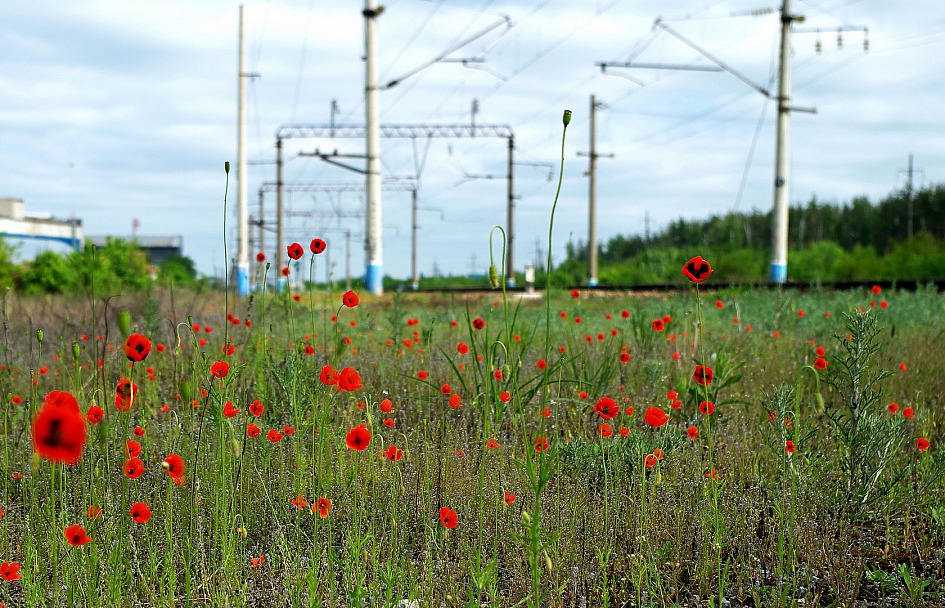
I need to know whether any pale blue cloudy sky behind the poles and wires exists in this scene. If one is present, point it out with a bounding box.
[0,0,945,278]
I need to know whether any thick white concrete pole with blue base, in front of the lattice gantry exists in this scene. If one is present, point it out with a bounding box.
[362,0,384,295]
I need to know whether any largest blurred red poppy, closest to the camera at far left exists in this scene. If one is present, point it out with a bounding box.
[33,391,88,464]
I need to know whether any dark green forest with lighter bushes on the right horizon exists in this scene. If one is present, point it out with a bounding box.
[553,185,945,285]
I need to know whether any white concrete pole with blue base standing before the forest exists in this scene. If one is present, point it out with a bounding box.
[770,0,795,284]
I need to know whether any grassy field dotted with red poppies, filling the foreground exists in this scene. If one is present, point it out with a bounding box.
[0,274,945,606]
